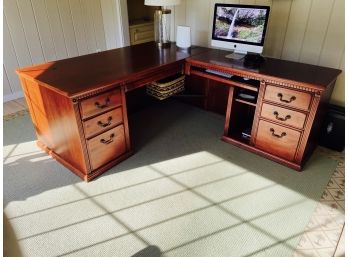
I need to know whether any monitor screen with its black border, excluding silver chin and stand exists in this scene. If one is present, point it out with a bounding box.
[212,4,270,46]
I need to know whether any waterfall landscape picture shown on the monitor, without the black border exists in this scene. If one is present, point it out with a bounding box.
[214,6,266,43]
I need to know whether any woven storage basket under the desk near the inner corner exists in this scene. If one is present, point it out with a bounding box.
[146,74,185,100]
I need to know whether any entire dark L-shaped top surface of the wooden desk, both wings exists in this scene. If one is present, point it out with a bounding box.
[17,42,341,97]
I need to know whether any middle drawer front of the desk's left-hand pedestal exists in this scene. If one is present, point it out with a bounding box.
[83,107,123,138]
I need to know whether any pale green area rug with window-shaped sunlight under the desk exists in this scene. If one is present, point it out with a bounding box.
[4,101,336,257]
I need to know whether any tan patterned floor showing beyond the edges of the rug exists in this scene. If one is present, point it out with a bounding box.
[4,98,345,254]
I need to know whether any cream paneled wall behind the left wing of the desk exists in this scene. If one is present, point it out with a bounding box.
[3,0,128,101]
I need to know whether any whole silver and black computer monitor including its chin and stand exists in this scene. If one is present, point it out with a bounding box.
[211,4,270,59]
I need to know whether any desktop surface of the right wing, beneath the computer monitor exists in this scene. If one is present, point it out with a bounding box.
[187,49,341,90]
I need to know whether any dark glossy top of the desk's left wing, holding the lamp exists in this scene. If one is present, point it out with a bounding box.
[17,42,210,97]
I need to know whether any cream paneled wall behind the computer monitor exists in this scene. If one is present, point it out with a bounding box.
[173,0,345,105]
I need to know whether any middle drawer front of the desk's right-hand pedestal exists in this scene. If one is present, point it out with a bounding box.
[261,103,306,129]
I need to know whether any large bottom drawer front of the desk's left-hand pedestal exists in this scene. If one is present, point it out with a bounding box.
[87,125,126,170]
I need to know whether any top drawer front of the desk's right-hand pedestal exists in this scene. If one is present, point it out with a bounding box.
[264,85,311,110]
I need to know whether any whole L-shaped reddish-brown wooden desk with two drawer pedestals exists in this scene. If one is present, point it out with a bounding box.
[17,42,341,181]
